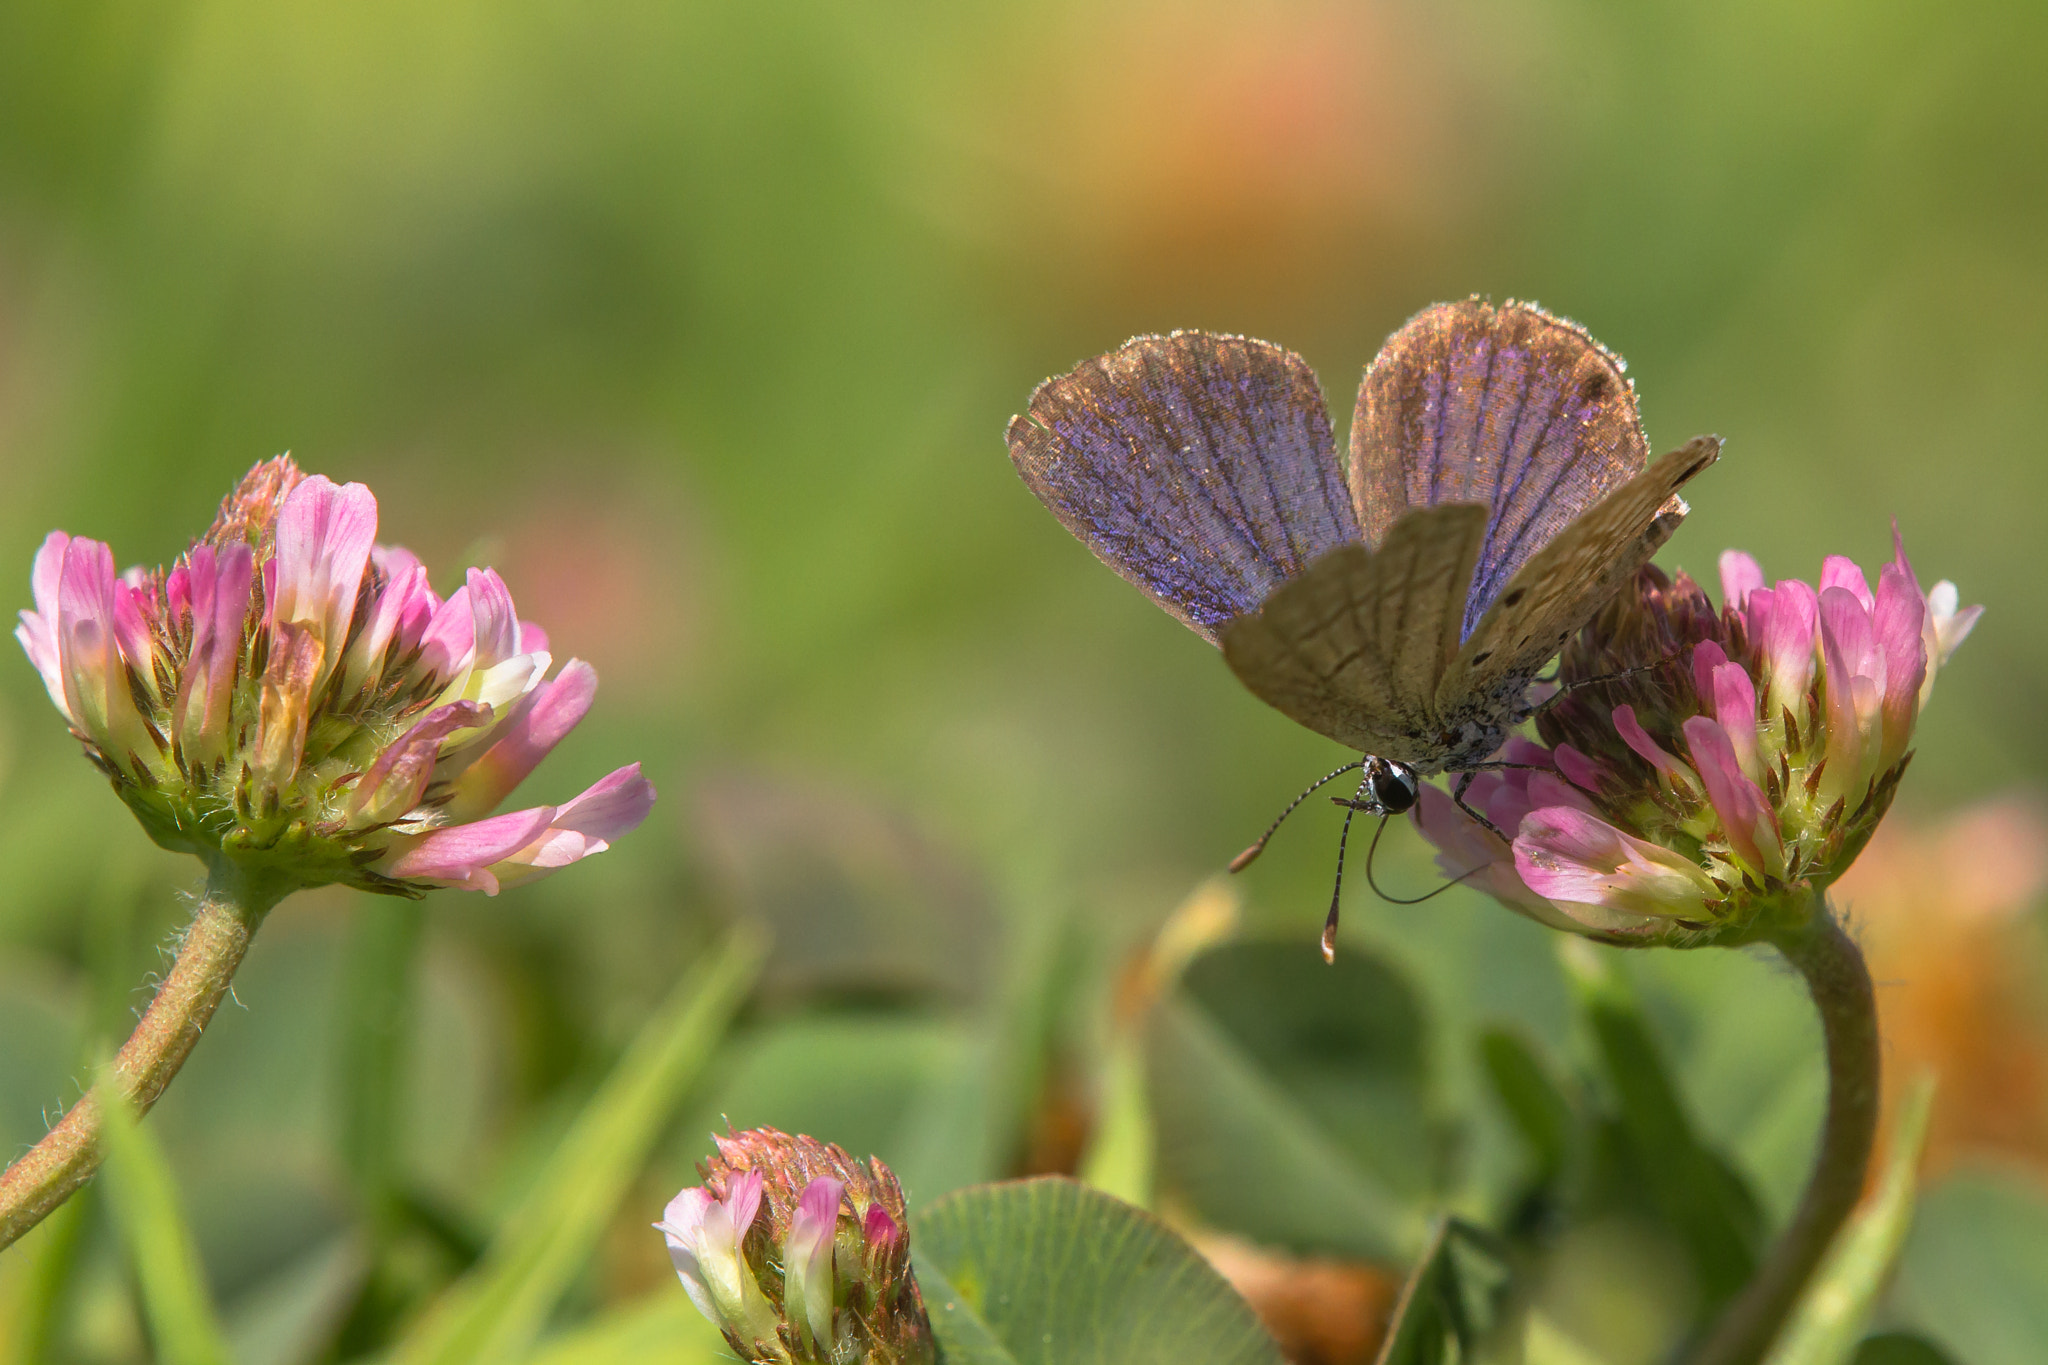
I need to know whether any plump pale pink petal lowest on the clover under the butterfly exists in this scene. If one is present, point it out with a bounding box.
[1516,806,1718,927]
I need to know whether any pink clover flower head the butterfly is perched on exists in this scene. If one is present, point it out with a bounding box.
[1415,528,1982,945]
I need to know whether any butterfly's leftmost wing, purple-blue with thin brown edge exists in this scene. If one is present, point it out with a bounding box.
[1008,332,1358,643]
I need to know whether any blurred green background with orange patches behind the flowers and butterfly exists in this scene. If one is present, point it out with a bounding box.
[0,0,2048,1361]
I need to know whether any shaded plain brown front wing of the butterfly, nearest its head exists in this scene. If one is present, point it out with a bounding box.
[1223,503,1487,763]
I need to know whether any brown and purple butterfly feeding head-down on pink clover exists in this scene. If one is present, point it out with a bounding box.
[1008,297,1720,954]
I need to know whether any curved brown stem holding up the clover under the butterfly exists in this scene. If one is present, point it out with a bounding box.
[1692,894,1878,1365]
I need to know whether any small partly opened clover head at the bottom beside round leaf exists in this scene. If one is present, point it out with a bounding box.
[655,1128,936,1365]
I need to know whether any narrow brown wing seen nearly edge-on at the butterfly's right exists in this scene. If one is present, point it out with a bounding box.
[1436,436,1720,714]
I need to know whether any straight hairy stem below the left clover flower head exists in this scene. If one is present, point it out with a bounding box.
[0,860,289,1248]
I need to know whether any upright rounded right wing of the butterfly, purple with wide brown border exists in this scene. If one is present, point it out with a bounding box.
[1352,299,1649,636]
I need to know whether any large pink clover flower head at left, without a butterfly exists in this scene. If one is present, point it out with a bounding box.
[14,456,653,894]
